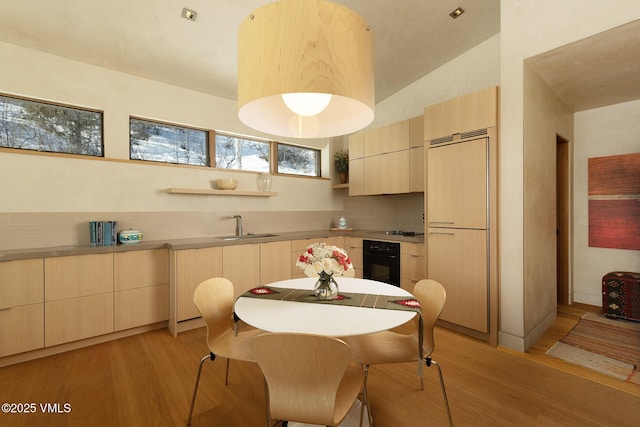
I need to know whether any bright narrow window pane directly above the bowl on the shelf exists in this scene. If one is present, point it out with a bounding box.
[216,133,271,172]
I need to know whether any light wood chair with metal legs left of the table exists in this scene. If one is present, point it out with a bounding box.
[187,277,265,425]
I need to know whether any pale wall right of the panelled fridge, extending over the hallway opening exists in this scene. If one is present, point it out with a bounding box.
[499,0,640,351]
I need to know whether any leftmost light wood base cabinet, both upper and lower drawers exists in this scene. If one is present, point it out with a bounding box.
[0,258,44,357]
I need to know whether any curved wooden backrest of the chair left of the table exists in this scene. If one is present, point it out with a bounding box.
[193,277,238,347]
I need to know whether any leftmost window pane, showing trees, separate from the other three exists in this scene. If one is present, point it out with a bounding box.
[0,96,104,157]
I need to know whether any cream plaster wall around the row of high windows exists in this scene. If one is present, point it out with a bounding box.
[0,39,342,212]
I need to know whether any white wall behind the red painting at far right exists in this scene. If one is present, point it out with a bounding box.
[573,100,640,306]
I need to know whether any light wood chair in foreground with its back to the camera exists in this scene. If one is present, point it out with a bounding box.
[251,333,368,426]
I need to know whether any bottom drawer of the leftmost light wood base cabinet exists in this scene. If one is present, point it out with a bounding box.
[0,303,44,357]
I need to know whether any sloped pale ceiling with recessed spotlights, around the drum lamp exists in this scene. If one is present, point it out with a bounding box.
[0,0,500,102]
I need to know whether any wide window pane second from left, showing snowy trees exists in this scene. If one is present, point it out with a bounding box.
[129,119,209,166]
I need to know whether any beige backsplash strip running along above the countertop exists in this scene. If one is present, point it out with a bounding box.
[0,193,424,250]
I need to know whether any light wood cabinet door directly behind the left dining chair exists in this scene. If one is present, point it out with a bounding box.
[170,247,223,327]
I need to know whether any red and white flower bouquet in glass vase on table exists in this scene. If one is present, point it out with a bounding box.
[296,243,353,299]
